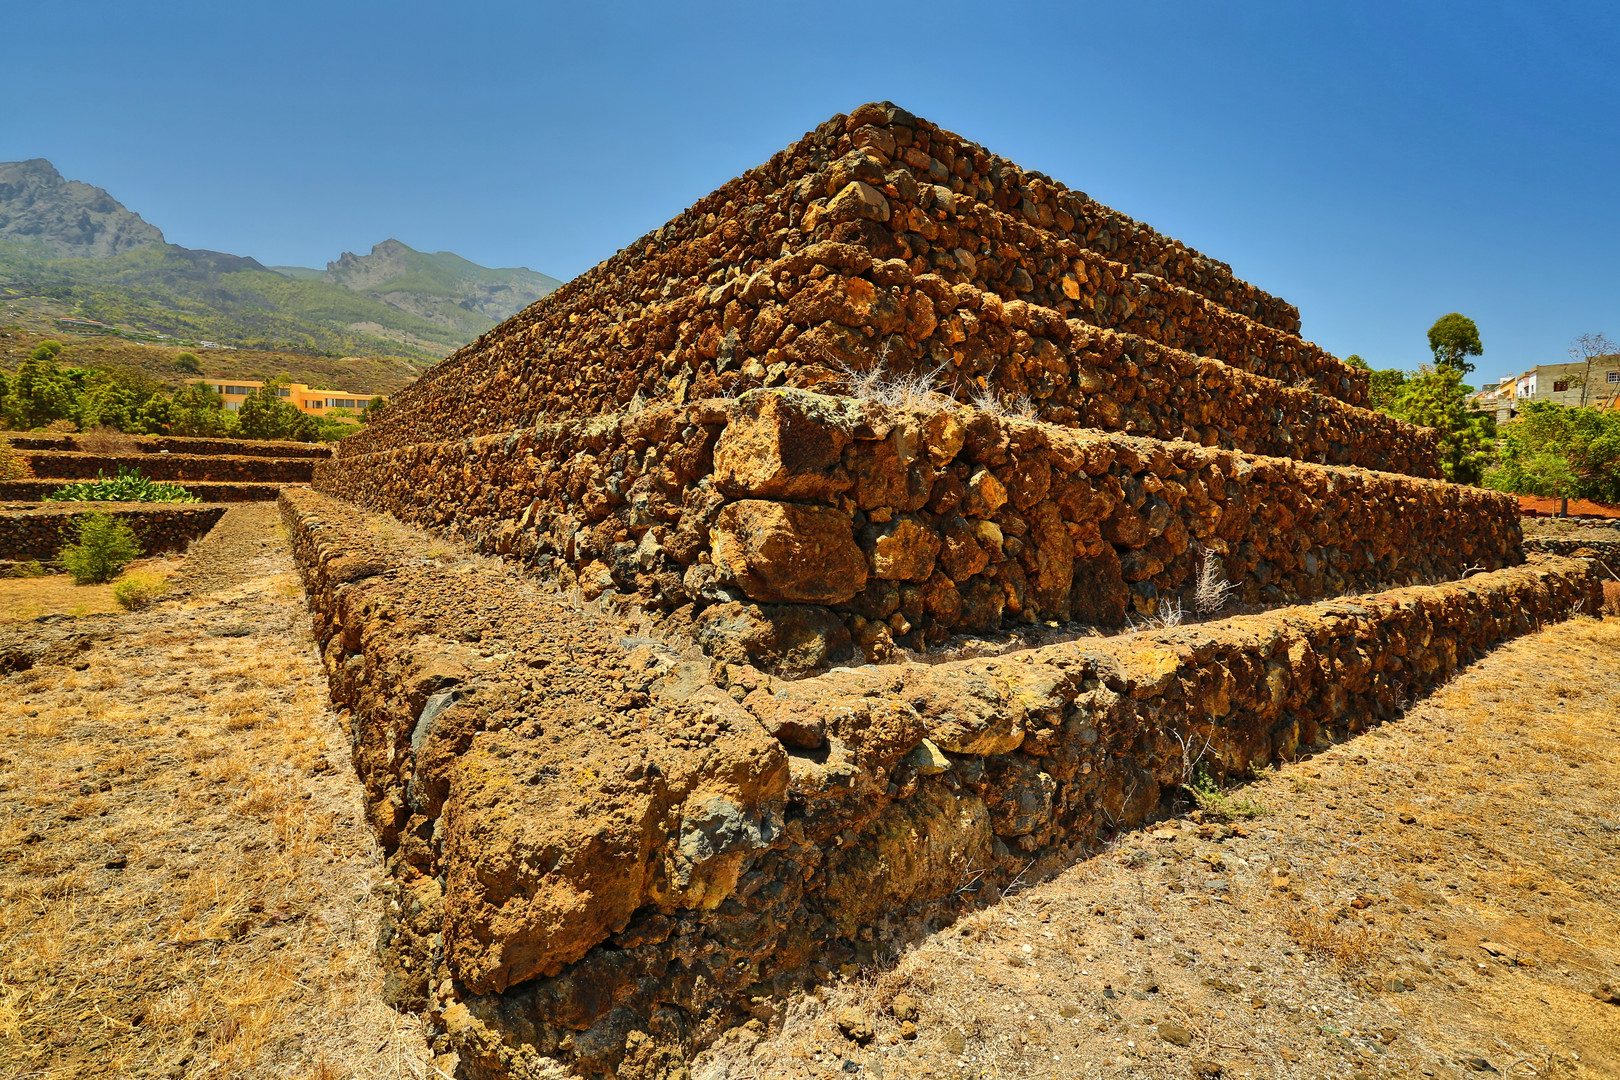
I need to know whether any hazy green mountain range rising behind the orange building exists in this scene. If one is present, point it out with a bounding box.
[0,159,559,363]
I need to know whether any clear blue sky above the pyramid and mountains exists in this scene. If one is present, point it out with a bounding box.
[0,0,1620,381]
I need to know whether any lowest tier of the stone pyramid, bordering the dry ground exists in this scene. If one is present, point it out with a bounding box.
[282,491,1597,1078]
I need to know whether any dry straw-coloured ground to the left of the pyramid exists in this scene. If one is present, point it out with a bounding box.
[0,504,429,1080]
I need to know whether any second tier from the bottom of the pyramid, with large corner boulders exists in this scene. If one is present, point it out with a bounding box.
[314,392,1521,670]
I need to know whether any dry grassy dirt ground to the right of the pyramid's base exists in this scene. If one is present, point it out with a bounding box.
[693,619,1620,1080]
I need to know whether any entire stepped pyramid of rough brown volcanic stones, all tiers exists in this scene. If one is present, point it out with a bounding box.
[284,104,1594,1077]
